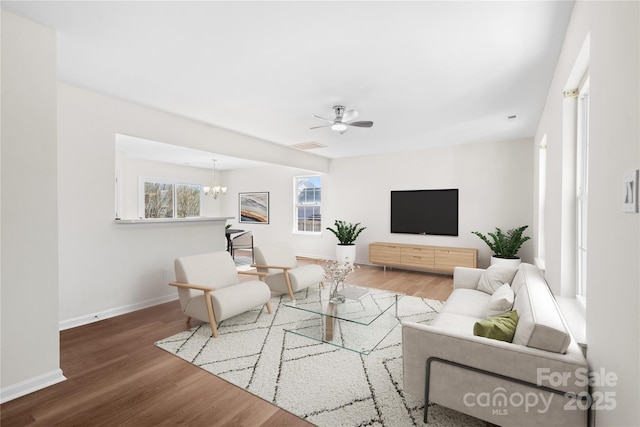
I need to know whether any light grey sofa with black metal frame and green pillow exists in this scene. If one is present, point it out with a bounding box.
[402,263,589,426]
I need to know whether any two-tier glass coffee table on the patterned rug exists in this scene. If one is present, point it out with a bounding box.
[284,284,403,354]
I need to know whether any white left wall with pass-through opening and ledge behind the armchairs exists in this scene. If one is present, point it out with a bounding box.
[58,84,328,327]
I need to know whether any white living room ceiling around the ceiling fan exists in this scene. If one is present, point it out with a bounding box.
[2,1,573,169]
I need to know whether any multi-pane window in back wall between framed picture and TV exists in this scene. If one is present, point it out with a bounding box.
[294,175,322,234]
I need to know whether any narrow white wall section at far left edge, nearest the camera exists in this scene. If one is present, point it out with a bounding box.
[0,12,64,401]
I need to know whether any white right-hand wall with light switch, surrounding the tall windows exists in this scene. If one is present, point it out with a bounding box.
[536,1,640,426]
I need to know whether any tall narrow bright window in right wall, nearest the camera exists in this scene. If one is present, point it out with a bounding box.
[576,76,589,305]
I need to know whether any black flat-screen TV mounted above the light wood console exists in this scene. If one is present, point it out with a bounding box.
[391,188,458,236]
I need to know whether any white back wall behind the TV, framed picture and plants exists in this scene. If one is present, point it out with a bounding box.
[222,139,533,266]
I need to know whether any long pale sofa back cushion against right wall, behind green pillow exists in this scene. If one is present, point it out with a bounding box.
[512,263,571,353]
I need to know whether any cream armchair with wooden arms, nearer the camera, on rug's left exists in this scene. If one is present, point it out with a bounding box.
[169,251,271,338]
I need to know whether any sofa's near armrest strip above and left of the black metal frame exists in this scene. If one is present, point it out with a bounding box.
[402,321,588,398]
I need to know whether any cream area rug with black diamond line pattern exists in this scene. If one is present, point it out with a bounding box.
[156,289,485,427]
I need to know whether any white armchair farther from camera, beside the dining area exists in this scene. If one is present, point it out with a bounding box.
[252,243,324,301]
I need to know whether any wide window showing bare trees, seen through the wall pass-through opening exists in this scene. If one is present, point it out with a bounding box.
[140,178,202,218]
